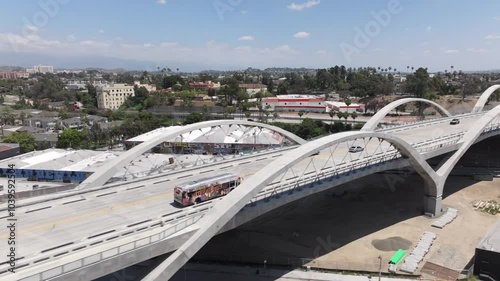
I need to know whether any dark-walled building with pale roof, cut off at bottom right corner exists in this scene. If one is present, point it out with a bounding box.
[474,221,500,280]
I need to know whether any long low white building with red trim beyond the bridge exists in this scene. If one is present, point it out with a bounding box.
[262,95,325,112]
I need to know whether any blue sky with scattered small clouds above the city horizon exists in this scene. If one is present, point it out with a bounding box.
[0,0,500,71]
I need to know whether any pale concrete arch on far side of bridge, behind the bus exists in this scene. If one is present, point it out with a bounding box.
[78,120,306,189]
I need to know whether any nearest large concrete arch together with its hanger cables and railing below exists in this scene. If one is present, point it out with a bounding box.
[143,132,437,280]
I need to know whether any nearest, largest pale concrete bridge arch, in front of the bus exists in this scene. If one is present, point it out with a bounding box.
[143,132,437,281]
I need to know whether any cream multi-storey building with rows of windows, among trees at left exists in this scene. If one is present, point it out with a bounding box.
[96,84,135,110]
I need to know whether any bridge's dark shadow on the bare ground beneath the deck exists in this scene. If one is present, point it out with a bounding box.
[193,171,476,268]
